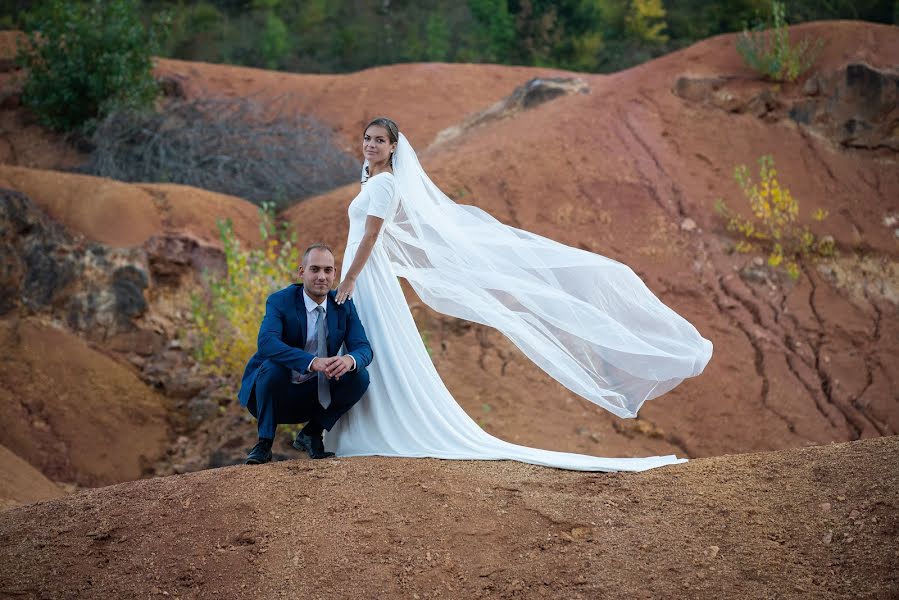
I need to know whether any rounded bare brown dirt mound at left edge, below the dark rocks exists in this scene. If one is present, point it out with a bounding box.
[0,317,168,488]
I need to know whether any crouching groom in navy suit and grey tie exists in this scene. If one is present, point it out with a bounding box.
[238,244,372,465]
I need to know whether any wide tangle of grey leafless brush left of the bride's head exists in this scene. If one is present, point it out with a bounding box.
[80,96,359,208]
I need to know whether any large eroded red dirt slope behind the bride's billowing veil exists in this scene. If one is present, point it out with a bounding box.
[286,22,899,457]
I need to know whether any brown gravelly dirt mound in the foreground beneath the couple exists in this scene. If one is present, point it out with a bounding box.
[0,437,899,600]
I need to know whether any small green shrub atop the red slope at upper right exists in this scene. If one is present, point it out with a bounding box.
[737,0,823,81]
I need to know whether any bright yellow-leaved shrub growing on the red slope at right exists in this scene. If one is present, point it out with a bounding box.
[715,155,834,279]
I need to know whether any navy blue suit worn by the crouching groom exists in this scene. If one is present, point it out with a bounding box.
[238,284,372,439]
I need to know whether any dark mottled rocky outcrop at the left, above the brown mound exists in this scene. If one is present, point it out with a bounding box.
[0,190,230,422]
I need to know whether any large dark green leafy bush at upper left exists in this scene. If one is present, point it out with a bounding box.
[16,0,158,131]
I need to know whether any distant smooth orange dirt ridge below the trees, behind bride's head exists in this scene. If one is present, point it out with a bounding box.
[156,59,576,151]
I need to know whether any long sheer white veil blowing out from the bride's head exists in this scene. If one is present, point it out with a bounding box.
[370,134,712,417]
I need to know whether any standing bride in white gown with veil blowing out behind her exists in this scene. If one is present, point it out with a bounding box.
[325,118,712,471]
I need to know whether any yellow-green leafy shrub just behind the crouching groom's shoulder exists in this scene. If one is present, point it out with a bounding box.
[188,203,299,386]
